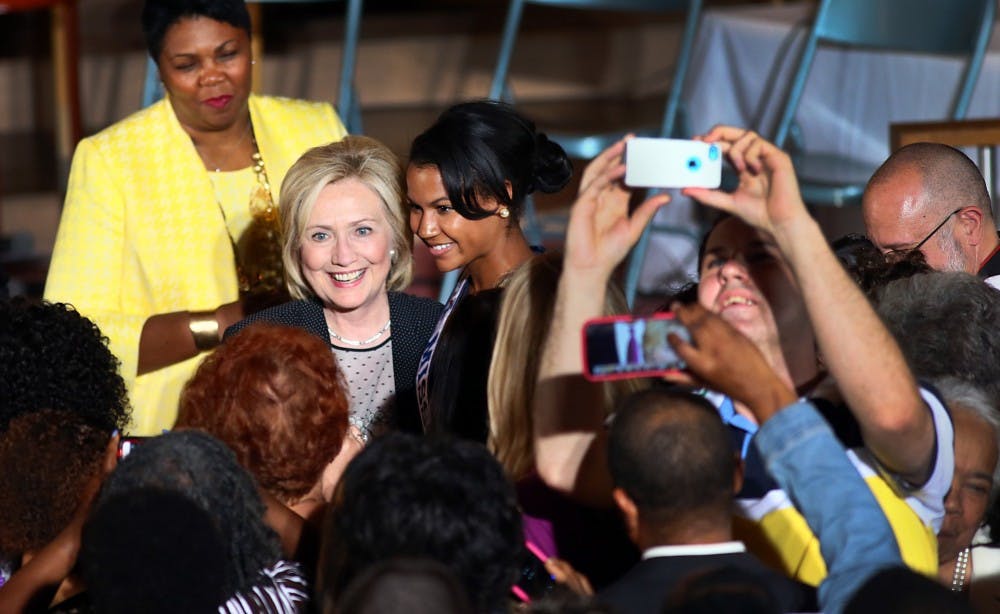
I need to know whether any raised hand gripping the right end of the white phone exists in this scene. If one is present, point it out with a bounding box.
[683,126,809,234]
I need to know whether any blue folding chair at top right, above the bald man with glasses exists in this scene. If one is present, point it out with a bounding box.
[771,0,996,207]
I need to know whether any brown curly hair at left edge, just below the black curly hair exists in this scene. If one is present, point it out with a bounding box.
[0,409,110,555]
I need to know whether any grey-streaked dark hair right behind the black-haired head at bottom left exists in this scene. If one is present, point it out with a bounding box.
[95,430,281,595]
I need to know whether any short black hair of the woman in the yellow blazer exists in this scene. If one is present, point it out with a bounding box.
[142,0,250,62]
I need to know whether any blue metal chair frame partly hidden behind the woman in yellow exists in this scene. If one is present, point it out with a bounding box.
[142,0,364,134]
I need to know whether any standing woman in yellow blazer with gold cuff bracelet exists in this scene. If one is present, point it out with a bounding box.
[45,0,345,435]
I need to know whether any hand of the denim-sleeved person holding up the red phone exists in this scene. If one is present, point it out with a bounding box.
[664,303,796,423]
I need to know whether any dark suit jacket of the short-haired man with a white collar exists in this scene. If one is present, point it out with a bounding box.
[598,552,816,614]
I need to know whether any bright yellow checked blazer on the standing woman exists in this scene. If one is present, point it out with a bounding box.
[45,96,346,435]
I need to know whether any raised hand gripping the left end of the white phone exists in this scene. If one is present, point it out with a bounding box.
[566,136,670,276]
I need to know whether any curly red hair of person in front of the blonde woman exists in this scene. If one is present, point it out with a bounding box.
[177,322,350,504]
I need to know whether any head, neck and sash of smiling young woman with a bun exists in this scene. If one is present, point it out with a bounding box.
[406,101,572,427]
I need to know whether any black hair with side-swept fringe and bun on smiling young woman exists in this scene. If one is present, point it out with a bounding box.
[410,100,573,220]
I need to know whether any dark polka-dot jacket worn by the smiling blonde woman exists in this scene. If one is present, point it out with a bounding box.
[225,292,444,433]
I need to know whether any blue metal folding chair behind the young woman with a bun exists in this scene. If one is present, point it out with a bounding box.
[440,0,702,304]
